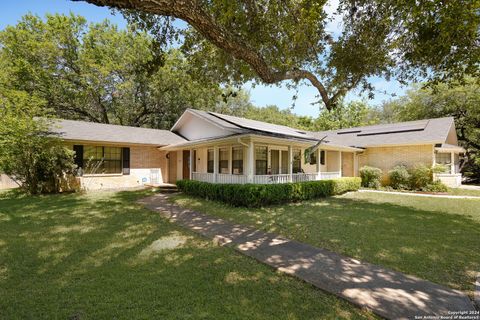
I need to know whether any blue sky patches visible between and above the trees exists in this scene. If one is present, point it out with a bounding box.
[0,0,405,117]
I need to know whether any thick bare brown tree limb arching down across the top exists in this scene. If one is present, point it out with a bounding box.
[72,0,339,110]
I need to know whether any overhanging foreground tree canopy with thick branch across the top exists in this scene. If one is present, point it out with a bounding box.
[74,0,480,109]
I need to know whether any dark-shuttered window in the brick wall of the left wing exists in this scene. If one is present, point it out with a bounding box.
[83,146,122,174]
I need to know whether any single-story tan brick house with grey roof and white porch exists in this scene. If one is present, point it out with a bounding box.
[0,109,465,189]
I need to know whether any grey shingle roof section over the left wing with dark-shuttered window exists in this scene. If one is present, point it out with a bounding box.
[52,119,186,146]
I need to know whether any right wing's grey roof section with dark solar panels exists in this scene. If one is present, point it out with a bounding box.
[310,117,455,148]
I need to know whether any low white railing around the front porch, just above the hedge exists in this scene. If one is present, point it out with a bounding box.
[192,172,341,184]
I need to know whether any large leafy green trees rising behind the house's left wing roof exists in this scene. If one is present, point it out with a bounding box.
[0,14,229,128]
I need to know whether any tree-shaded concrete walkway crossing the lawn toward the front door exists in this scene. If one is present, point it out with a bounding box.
[140,194,475,319]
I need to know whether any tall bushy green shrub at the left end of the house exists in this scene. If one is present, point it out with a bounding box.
[0,90,75,194]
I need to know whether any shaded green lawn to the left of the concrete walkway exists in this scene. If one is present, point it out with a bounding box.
[0,191,373,319]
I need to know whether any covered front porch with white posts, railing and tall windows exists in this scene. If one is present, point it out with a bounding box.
[163,136,359,184]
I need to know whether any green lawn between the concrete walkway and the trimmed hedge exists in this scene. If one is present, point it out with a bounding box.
[174,192,480,295]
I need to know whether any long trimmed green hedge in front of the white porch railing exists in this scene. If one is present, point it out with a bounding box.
[177,177,361,207]
